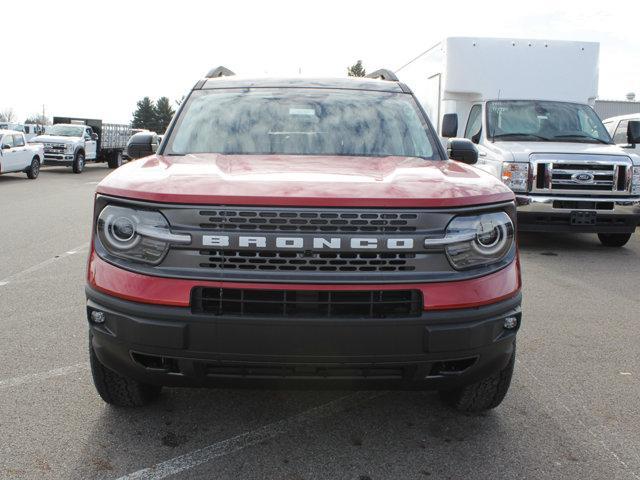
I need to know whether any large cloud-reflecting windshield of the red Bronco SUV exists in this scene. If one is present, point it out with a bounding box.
[163,88,440,159]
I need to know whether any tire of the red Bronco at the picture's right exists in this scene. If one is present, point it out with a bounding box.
[440,345,516,413]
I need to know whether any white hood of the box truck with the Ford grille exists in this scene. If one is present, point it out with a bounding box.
[485,142,632,162]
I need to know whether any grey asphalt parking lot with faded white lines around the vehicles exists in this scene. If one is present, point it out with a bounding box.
[0,165,640,480]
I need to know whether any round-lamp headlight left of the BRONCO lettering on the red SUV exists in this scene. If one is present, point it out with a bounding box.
[96,205,191,265]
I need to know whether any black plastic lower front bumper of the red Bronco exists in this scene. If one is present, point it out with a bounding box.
[87,288,521,389]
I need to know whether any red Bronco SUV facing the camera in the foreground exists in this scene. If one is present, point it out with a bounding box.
[86,69,521,411]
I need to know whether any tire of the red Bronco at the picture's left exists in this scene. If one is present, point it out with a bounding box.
[89,340,162,407]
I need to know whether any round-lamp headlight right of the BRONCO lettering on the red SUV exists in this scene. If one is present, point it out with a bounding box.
[425,212,514,270]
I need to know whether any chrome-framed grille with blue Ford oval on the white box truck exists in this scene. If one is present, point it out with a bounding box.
[532,155,632,195]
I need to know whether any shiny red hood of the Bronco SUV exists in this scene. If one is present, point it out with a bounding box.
[97,154,514,207]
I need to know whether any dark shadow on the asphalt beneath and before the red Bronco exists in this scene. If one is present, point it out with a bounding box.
[73,378,553,479]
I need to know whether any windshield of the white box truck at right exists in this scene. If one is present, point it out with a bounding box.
[487,100,612,144]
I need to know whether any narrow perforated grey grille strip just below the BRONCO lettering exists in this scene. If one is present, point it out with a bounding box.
[200,250,420,272]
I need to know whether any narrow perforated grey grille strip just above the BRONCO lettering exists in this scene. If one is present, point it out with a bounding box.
[200,208,418,233]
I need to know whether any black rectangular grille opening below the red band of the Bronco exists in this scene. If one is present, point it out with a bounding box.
[191,287,422,318]
